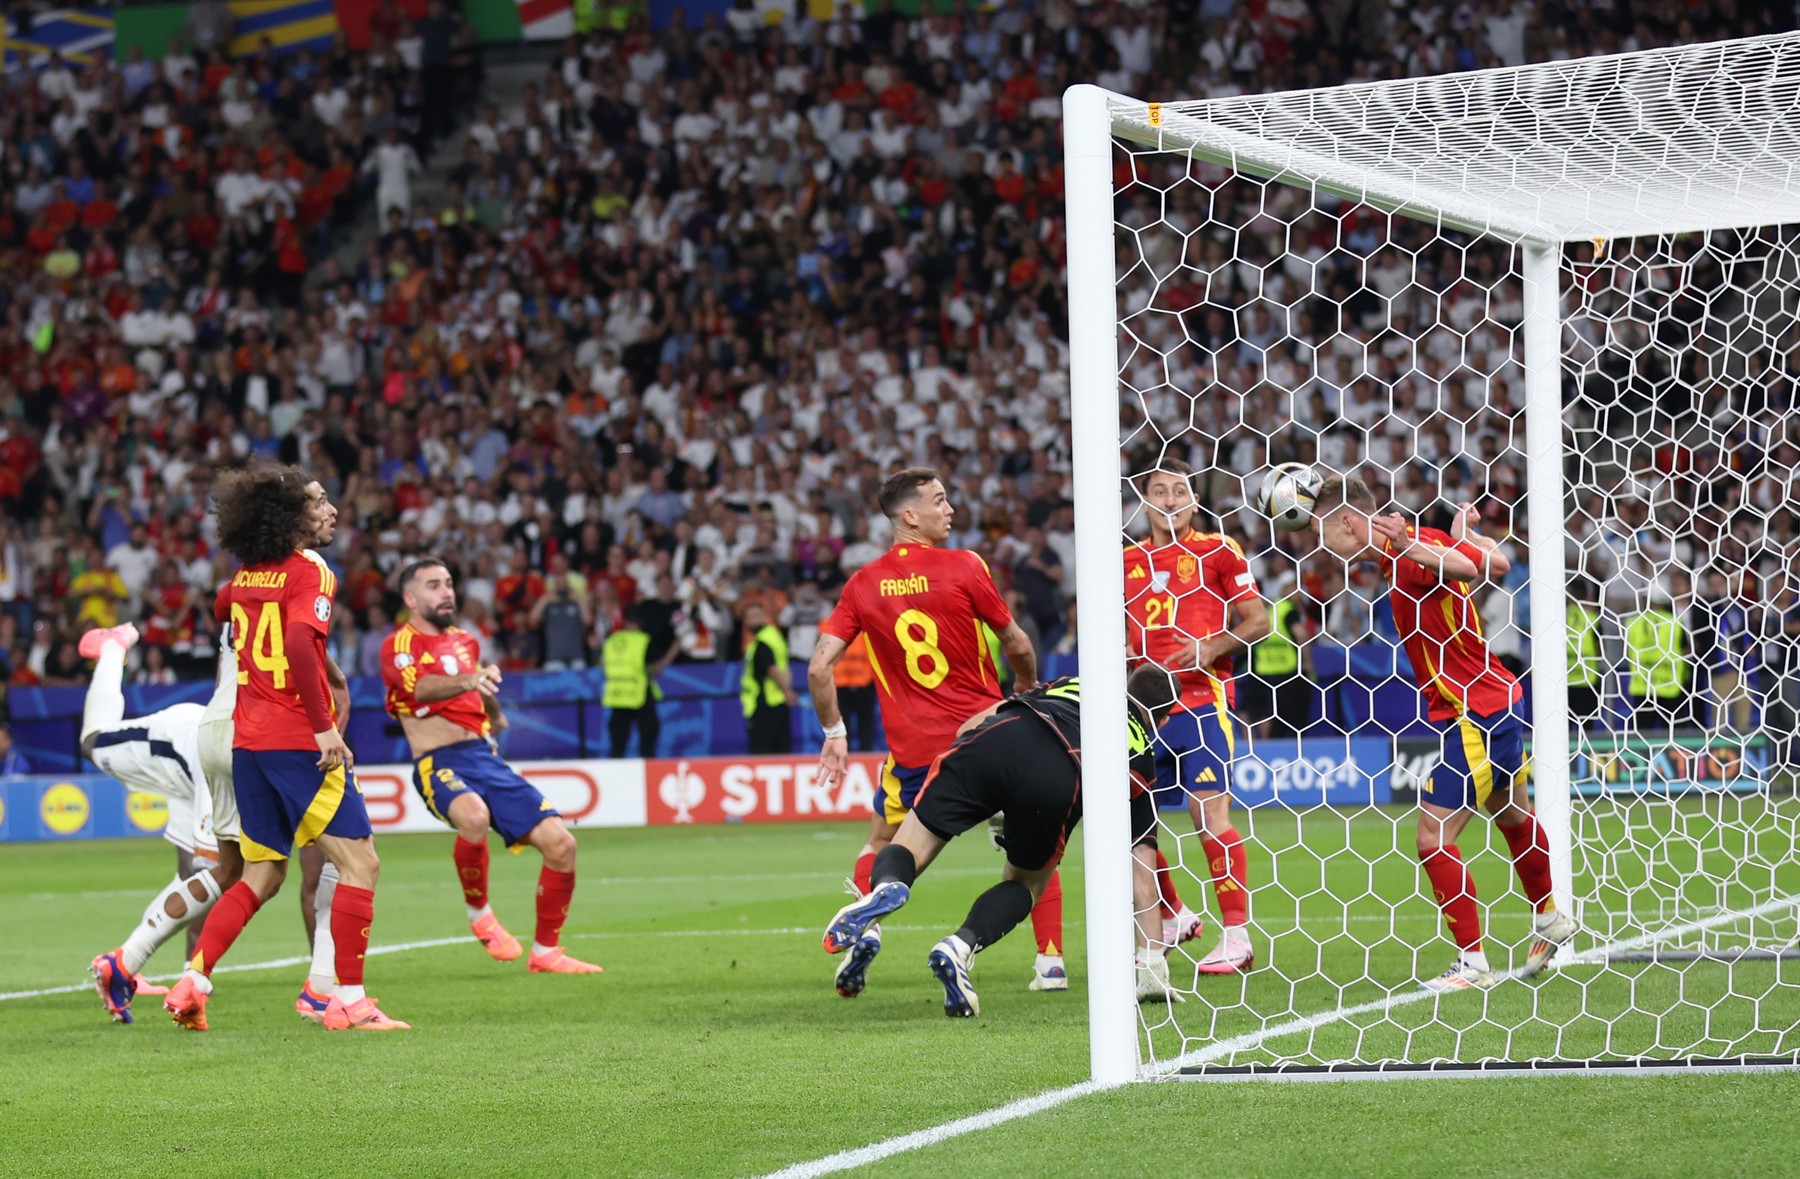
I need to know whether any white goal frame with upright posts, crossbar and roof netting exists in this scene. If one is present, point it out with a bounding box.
[1064,34,1800,1082]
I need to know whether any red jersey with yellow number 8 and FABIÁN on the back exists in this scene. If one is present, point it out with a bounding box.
[819,544,1012,769]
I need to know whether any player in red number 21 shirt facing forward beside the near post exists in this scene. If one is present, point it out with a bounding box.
[1125,459,1269,974]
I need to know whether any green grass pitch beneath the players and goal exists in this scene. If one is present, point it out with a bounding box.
[0,812,1800,1175]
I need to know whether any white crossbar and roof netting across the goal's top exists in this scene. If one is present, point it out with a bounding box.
[1109,32,1800,243]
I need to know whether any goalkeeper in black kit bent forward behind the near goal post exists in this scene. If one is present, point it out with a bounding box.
[824,668,1175,1017]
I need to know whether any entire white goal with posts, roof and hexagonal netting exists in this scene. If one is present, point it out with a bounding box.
[1066,36,1800,1080]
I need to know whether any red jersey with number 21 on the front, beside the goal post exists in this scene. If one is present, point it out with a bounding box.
[1125,531,1256,709]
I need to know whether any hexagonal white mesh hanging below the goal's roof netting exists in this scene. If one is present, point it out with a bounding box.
[1071,39,1800,1075]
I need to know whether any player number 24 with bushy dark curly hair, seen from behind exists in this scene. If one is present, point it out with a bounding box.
[162,464,409,1031]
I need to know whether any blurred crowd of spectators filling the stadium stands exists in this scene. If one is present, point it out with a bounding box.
[0,0,1800,748]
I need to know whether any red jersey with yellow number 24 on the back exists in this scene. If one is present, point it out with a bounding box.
[214,549,337,751]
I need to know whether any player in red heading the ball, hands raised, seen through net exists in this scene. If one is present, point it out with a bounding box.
[1312,475,1577,992]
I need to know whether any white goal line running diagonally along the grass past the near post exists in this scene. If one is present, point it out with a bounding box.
[761,896,1800,1179]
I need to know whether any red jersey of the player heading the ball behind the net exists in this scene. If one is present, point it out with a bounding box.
[1381,527,1525,720]
